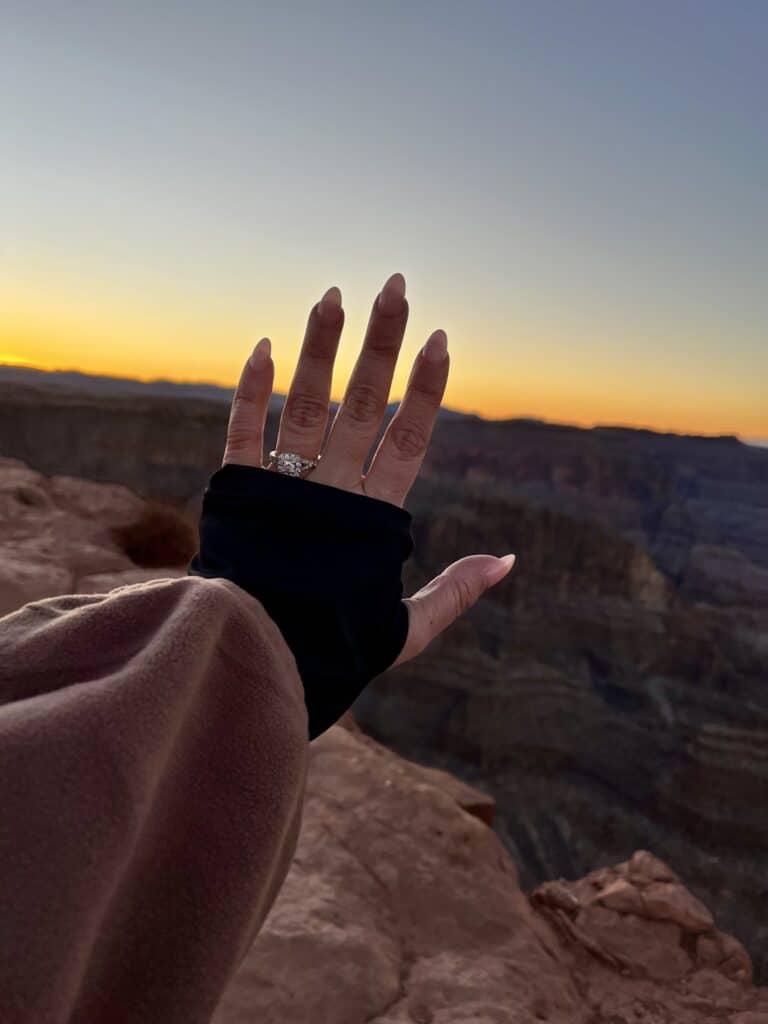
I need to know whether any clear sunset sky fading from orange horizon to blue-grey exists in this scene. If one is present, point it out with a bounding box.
[0,0,768,438]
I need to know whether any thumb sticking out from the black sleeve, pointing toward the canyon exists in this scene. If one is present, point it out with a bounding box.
[393,554,515,666]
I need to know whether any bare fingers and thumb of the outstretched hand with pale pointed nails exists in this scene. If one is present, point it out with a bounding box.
[223,273,515,665]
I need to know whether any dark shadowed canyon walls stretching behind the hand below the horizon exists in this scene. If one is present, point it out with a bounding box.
[0,368,768,983]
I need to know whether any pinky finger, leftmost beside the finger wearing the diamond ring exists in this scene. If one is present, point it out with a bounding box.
[222,338,274,468]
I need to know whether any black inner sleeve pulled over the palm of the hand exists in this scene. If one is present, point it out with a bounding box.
[188,464,414,739]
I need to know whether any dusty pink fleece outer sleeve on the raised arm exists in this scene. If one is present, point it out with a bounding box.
[0,577,307,1024]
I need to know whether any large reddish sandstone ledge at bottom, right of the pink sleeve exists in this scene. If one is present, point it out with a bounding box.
[214,726,768,1024]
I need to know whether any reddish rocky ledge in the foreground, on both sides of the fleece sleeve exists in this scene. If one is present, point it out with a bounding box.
[0,459,768,1024]
